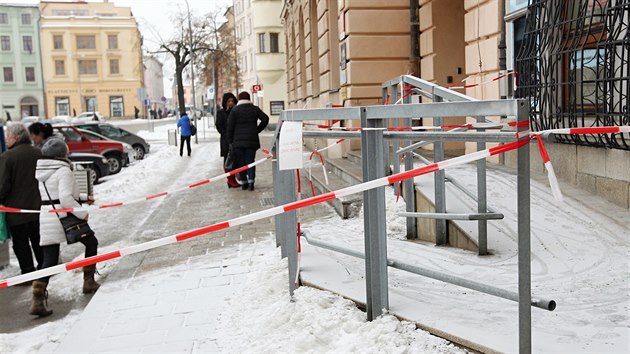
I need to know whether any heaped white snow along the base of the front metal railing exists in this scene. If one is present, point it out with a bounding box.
[217,241,465,353]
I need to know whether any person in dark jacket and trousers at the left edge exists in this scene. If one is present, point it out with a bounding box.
[0,123,44,276]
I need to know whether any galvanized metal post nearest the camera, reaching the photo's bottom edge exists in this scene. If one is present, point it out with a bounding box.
[516,100,532,354]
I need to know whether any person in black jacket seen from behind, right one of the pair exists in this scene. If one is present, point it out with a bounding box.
[227,91,269,191]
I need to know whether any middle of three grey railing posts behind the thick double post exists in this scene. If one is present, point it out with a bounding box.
[433,95,448,245]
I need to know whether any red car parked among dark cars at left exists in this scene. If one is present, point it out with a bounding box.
[54,125,129,175]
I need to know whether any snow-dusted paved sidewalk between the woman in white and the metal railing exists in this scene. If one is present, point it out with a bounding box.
[53,136,332,353]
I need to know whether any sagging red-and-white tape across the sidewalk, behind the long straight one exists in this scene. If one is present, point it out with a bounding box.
[0,149,273,214]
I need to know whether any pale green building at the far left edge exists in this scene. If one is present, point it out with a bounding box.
[0,4,46,121]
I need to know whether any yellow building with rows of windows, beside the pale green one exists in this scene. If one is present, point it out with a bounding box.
[40,1,144,117]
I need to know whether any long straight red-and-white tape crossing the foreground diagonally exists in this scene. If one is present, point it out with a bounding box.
[0,137,532,288]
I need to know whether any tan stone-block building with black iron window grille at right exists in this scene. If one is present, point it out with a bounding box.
[282,0,630,208]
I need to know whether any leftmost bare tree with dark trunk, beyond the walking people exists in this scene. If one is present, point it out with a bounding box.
[153,11,215,114]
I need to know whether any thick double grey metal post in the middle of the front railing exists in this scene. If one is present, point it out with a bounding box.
[361,108,389,321]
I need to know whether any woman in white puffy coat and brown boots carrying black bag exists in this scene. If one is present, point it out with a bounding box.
[29,139,100,317]
